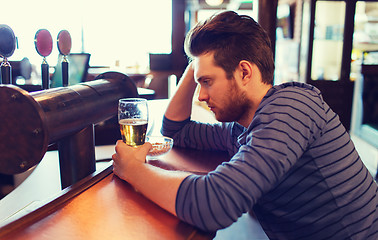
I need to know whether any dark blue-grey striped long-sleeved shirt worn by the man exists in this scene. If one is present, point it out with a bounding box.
[162,83,378,240]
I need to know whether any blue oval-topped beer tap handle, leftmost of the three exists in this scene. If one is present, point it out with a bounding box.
[0,24,16,84]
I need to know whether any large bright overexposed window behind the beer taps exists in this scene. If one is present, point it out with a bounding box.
[0,0,172,73]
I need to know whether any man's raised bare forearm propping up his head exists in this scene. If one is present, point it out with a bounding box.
[165,65,197,121]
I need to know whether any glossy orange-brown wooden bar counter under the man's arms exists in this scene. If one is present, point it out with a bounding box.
[0,101,228,240]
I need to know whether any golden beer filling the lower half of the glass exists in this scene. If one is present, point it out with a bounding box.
[119,119,148,147]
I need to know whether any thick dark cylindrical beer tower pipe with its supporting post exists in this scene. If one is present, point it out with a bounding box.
[0,72,139,188]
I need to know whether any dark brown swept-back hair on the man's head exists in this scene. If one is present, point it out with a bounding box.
[185,11,274,84]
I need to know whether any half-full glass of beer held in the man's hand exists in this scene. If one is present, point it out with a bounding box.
[118,98,148,147]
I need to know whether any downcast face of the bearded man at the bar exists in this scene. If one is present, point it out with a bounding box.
[193,53,249,122]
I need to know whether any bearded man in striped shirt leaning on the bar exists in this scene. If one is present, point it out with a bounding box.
[113,12,378,239]
